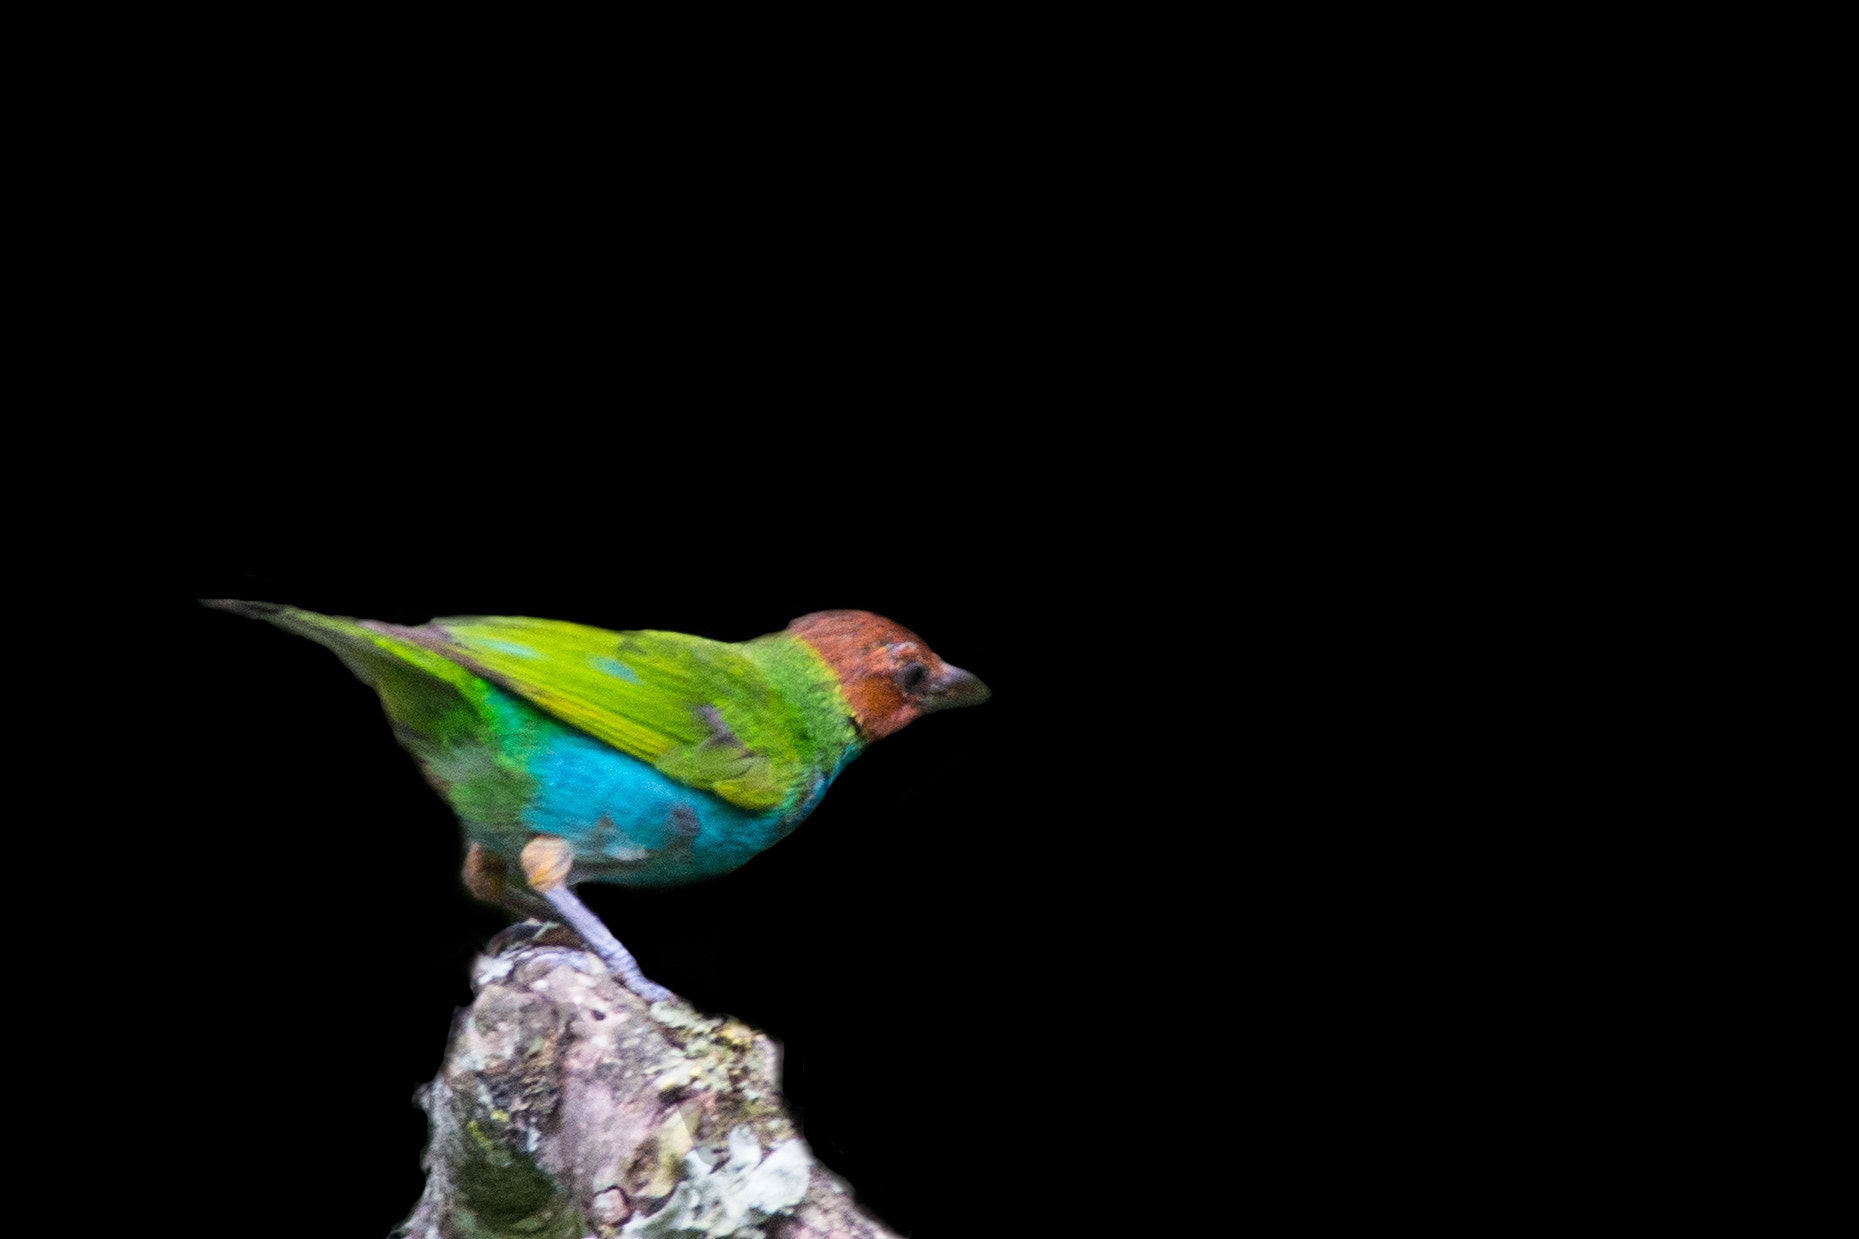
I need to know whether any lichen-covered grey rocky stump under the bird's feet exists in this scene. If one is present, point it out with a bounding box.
[394,923,894,1239]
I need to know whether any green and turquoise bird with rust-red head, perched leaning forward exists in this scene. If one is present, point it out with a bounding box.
[206,599,989,1001]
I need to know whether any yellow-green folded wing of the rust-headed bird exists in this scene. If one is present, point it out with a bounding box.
[409,616,811,809]
